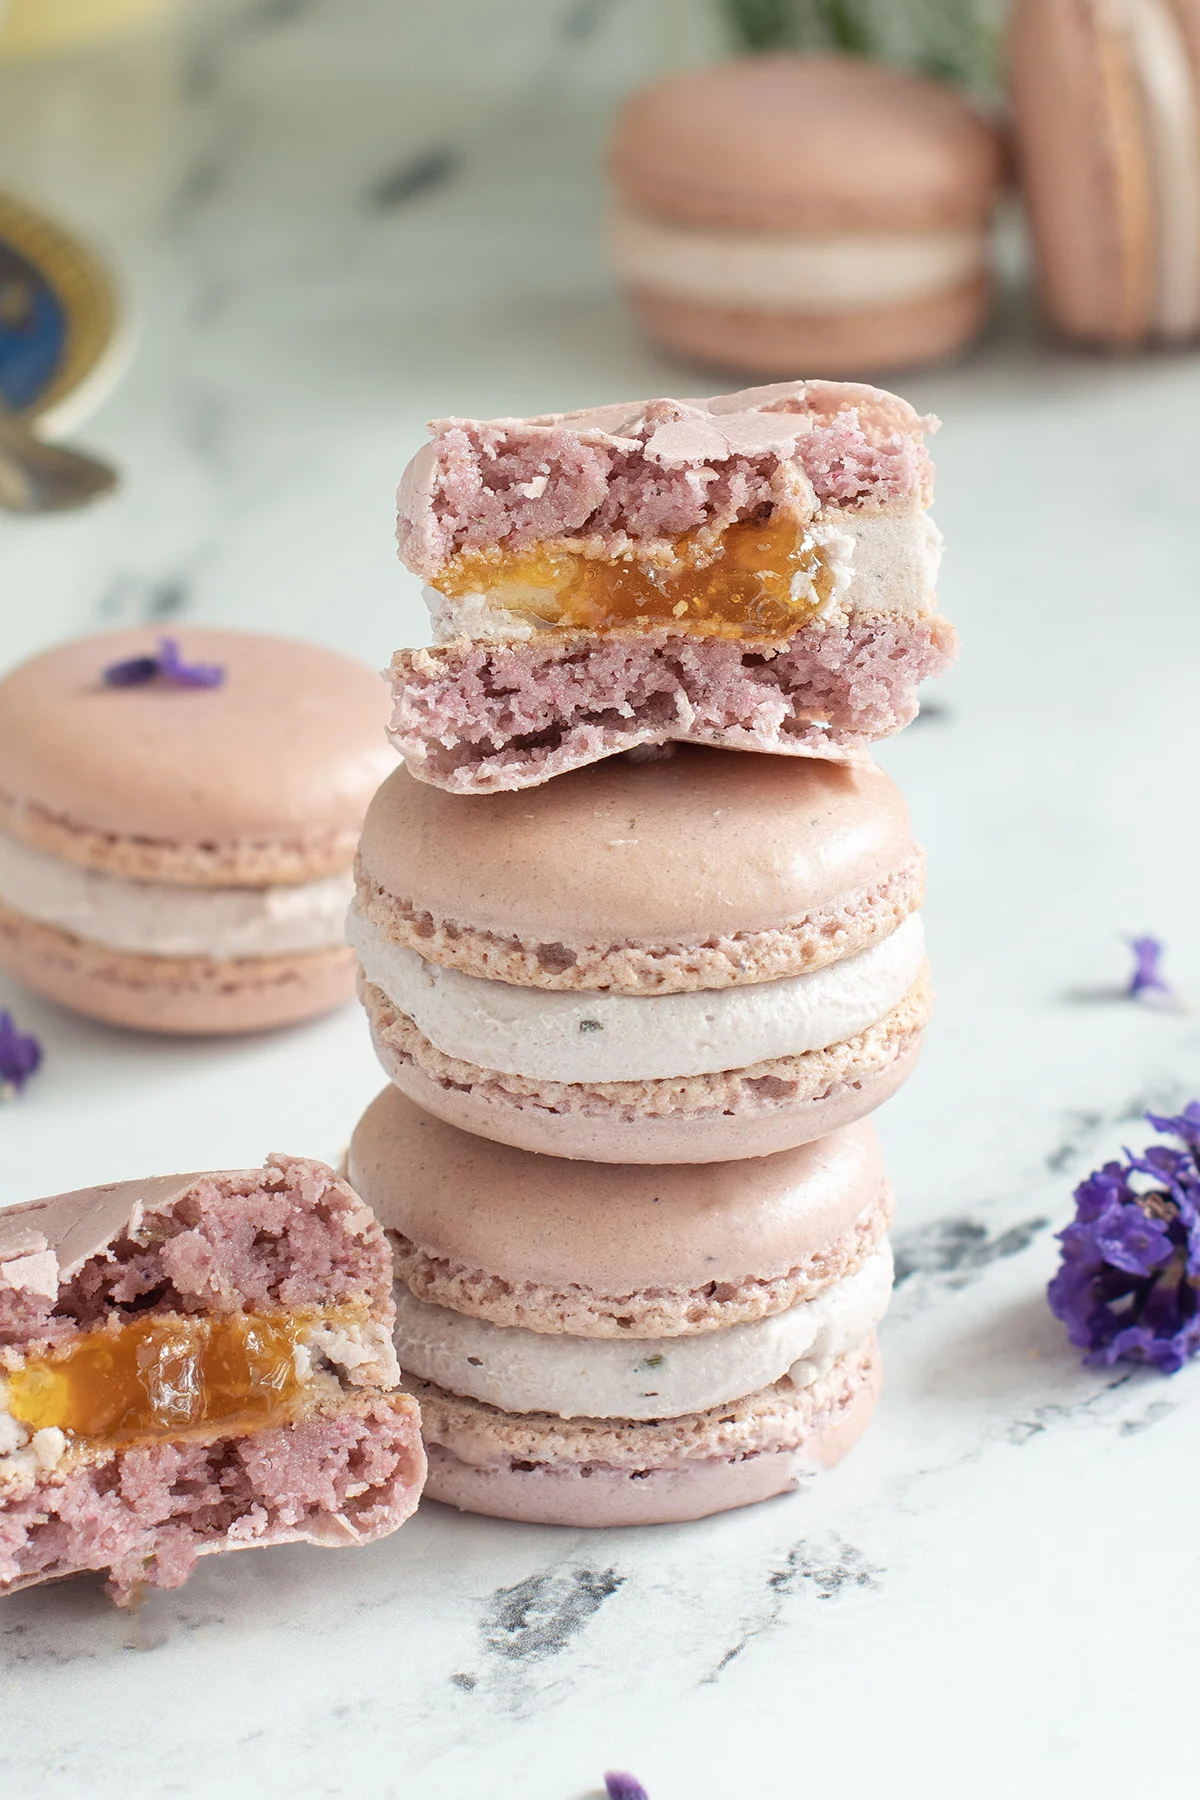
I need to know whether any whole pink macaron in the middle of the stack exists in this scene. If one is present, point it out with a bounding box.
[347,745,930,1163]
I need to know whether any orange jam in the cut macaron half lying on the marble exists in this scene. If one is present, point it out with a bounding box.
[4,1312,332,1444]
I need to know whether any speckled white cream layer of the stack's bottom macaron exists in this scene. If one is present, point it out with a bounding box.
[396,1242,892,1418]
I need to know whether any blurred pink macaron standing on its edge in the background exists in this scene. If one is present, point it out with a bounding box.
[1011,0,1200,349]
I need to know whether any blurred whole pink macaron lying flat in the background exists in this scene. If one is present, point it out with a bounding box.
[610,56,1000,376]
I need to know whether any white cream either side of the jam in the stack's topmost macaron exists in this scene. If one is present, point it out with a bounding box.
[425,508,943,644]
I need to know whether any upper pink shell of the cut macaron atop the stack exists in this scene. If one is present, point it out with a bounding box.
[398,382,937,578]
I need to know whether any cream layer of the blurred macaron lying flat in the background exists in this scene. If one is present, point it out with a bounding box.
[610,211,986,313]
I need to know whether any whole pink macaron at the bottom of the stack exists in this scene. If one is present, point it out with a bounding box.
[349,1089,892,1526]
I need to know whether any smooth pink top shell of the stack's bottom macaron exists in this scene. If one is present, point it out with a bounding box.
[347,1087,892,1337]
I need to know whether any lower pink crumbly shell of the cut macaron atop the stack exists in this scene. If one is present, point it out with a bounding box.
[390,616,955,794]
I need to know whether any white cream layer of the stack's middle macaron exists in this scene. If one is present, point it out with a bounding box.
[347,907,925,1084]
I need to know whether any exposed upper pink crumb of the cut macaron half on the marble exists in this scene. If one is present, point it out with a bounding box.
[0,1156,390,1350]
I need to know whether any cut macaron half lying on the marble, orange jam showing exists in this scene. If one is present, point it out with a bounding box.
[0,1157,425,1604]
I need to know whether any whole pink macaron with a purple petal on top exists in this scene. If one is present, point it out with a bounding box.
[0,626,396,1033]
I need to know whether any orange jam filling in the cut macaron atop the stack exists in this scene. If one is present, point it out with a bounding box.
[434,518,833,637]
